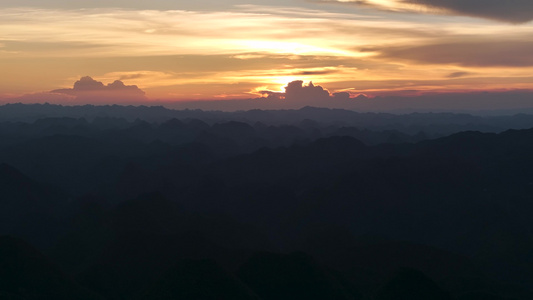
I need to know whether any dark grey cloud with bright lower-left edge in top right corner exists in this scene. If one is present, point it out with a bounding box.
[326,0,533,23]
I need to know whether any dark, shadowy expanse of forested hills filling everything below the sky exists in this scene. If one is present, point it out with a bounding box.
[0,105,533,300]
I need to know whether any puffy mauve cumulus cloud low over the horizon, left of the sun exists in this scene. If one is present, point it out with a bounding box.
[50,76,147,103]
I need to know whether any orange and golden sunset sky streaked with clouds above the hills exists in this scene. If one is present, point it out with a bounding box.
[0,0,533,110]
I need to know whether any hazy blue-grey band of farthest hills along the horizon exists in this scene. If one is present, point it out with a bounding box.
[5,104,533,134]
